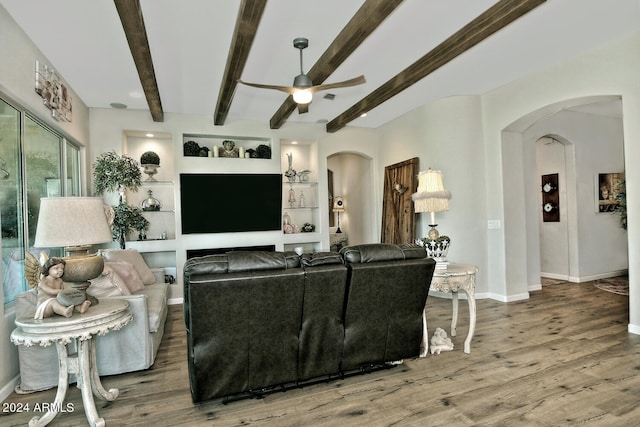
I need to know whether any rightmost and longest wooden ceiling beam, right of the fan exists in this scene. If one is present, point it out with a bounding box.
[326,0,546,133]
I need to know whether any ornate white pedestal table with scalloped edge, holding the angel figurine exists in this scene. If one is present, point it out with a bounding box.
[11,298,133,426]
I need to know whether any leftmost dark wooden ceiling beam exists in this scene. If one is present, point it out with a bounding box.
[114,0,164,122]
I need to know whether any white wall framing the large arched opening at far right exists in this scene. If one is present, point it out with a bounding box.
[483,33,640,333]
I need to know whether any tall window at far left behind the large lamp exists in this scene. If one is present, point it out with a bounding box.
[0,98,81,304]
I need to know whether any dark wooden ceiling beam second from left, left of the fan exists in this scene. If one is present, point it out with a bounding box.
[213,0,267,126]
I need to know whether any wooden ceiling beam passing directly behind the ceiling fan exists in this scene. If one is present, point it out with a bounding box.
[269,0,402,129]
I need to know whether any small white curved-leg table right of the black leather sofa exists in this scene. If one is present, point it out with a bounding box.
[420,263,478,357]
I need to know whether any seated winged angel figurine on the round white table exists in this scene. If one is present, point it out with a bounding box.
[26,252,91,319]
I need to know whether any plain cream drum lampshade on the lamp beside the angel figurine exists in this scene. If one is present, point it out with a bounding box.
[34,197,112,248]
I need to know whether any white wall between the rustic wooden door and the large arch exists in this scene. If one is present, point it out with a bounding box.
[377,96,488,297]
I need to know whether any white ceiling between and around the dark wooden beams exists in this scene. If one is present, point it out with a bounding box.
[0,0,640,127]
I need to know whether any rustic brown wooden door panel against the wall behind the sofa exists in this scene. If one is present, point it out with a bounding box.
[381,157,418,244]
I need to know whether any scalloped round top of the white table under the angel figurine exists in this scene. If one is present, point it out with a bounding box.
[11,298,133,346]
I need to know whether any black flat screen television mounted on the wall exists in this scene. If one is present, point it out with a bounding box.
[180,173,282,234]
